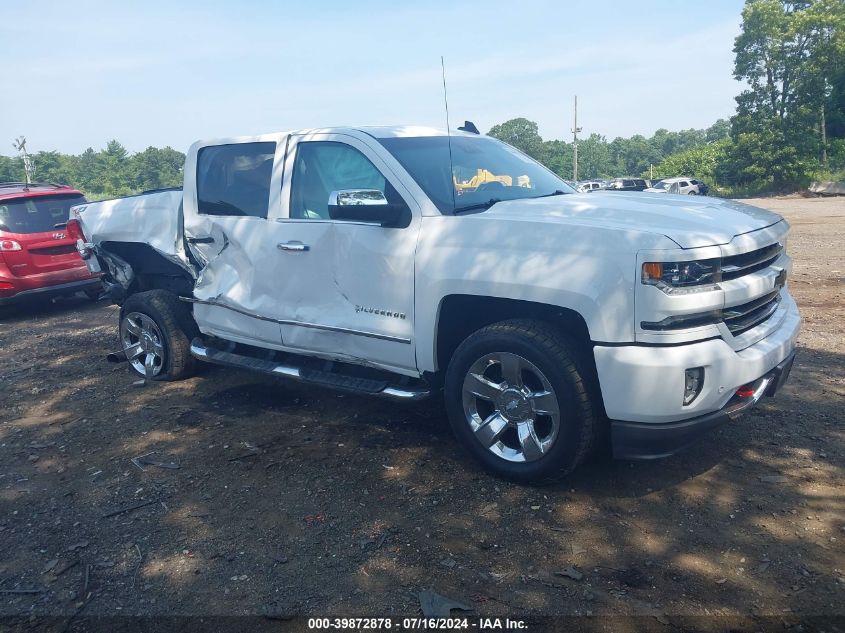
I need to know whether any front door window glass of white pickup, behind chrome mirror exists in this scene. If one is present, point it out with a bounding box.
[290,141,390,220]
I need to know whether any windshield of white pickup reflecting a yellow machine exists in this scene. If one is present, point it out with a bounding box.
[378,136,574,214]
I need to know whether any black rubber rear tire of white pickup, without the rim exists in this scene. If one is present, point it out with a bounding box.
[120,290,199,381]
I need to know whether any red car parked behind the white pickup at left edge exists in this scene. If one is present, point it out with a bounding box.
[0,182,101,305]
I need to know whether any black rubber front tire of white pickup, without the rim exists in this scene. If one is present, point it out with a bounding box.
[444,319,601,483]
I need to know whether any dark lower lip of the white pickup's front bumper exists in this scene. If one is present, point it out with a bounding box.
[611,351,795,459]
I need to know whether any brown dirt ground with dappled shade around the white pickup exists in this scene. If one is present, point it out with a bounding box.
[0,198,845,631]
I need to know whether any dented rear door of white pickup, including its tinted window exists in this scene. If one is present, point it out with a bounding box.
[185,134,286,349]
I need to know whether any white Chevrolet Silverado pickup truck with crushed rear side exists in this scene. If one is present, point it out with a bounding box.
[68,127,800,481]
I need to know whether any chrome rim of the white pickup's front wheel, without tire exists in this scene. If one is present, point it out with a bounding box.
[463,352,560,462]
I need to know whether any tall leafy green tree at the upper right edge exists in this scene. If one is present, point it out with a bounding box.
[730,0,845,189]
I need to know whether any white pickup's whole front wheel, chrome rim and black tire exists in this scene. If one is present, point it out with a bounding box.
[445,320,598,482]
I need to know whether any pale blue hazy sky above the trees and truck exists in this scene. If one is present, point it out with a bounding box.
[0,0,743,155]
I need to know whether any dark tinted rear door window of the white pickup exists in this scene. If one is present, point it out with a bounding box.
[197,143,276,218]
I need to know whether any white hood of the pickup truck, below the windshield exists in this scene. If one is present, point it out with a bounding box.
[479,191,783,248]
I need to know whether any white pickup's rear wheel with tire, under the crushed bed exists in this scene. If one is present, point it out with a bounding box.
[120,290,198,380]
